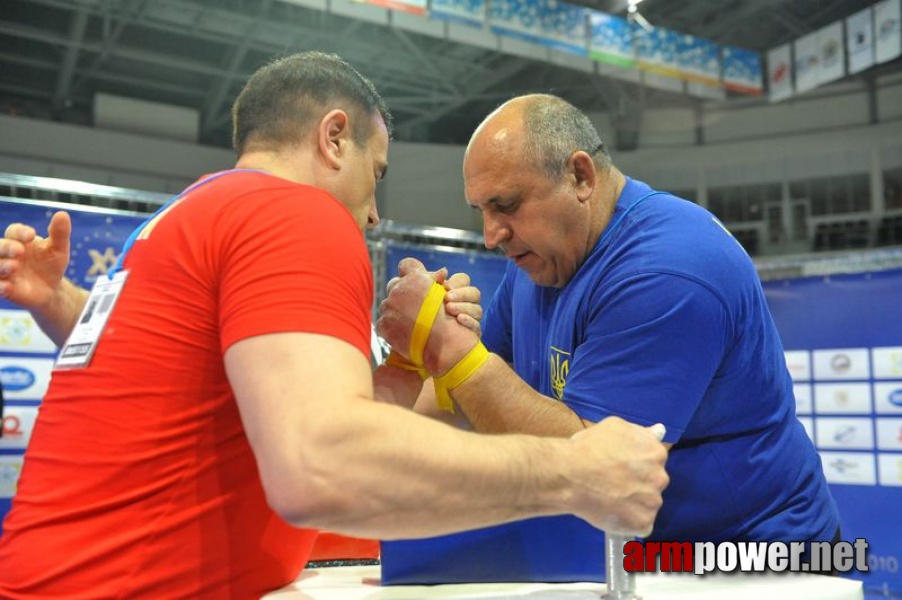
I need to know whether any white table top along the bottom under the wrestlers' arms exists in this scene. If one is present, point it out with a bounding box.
[263,566,864,600]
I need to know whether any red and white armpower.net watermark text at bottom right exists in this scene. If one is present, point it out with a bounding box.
[623,538,868,575]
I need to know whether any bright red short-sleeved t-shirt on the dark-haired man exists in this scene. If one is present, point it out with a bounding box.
[0,171,373,600]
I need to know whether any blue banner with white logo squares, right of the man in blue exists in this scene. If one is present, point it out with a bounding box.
[764,269,902,593]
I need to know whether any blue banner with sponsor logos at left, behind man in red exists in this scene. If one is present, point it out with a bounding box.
[0,198,147,531]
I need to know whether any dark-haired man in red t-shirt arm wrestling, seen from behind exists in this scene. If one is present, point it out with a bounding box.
[0,53,667,599]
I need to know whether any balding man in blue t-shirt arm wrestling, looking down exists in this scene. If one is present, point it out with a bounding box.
[381,95,839,542]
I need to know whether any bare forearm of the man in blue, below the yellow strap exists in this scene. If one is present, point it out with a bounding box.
[451,354,588,436]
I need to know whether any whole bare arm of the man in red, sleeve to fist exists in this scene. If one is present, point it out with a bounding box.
[225,333,666,538]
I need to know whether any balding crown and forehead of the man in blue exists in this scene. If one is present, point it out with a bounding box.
[464,94,611,179]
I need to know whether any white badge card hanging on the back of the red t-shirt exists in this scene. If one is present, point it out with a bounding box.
[53,271,128,369]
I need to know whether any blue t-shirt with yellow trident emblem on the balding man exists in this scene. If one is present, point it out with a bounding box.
[483,180,839,542]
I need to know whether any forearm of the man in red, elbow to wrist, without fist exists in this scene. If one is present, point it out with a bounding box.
[284,403,588,539]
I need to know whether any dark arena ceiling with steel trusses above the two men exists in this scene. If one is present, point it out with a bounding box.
[0,0,899,146]
